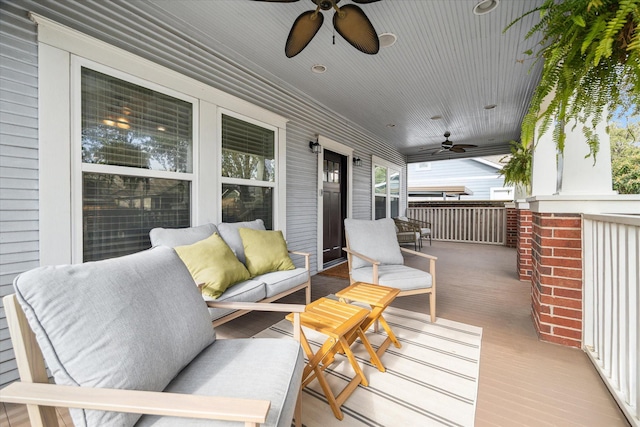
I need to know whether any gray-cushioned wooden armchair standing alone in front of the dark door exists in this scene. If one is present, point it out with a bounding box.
[343,218,437,322]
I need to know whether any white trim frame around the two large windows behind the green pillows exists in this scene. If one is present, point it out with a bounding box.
[30,13,288,265]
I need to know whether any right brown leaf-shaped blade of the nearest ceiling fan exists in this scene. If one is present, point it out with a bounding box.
[333,4,380,55]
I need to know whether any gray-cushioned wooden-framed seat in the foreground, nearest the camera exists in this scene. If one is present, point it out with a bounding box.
[0,247,304,427]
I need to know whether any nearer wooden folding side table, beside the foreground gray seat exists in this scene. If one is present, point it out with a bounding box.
[286,298,374,420]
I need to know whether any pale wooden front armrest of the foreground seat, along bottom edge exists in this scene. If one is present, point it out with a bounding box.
[0,382,271,426]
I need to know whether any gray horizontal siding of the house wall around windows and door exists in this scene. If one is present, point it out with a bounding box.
[0,0,405,383]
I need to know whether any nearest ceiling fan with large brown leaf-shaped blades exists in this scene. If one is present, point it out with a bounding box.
[254,0,380,58]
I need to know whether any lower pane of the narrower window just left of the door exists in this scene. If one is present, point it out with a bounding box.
[222,184,273,230]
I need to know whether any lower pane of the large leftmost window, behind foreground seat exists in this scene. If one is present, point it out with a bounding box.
[82,173,191,261]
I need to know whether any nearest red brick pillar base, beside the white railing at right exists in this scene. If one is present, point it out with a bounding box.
[531,213,582,348]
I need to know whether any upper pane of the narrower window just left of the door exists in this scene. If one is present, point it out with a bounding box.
[222,115,276,182]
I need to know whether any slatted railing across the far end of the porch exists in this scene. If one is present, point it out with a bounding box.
[407,206,507,245]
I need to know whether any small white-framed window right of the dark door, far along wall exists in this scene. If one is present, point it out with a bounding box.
[373,157,400,219]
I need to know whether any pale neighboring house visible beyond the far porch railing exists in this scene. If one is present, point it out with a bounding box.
[407,156,514,202]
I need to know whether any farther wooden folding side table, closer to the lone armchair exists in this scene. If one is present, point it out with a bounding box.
[336,282,401,372]
